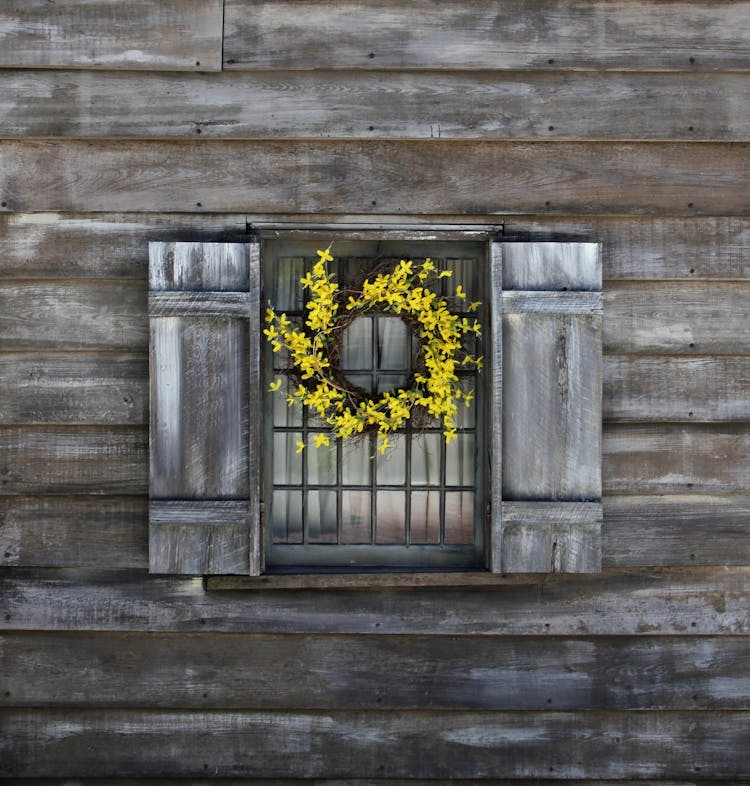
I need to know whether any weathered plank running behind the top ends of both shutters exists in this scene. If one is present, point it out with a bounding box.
[0,213,750,281]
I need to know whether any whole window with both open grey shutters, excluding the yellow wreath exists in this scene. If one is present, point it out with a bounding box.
[149,231,601,575]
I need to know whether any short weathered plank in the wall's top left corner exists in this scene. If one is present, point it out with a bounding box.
[0,0,222,71]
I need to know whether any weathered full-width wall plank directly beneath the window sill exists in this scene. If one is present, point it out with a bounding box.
[0,566,750,636]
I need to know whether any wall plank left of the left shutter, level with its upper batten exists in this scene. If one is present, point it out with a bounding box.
[0,279,148,352]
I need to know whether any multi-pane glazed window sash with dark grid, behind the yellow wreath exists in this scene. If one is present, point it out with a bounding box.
[264,241,486,571]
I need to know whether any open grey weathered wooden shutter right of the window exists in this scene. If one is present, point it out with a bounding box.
[490,243,602,573]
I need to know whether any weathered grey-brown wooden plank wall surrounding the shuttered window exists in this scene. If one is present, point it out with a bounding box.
[0,0,750,786]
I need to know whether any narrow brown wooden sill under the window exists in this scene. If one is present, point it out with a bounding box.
[205,571,545,590]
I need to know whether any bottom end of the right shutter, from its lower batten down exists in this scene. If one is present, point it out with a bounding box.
[502,502,602,573]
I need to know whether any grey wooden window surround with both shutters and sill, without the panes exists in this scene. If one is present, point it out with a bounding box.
[149,227,602,589]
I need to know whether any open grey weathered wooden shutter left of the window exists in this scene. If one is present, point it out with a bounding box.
[149,243,262,575]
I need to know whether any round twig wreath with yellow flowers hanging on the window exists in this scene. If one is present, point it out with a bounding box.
[263,247,482,453]
